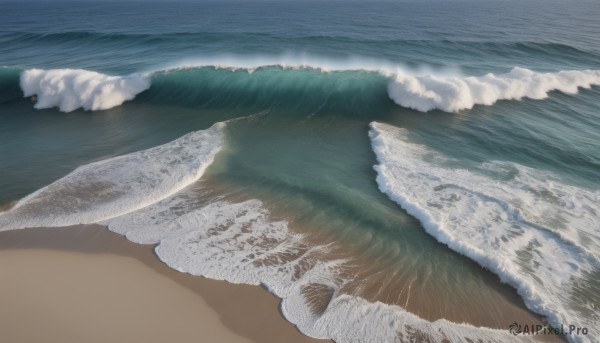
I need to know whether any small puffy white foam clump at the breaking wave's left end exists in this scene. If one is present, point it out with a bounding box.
[21,69,150,112]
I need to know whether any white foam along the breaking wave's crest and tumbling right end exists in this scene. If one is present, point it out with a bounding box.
[167,55,600,112]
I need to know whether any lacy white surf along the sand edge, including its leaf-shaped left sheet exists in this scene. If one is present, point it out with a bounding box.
[0,119,548,342]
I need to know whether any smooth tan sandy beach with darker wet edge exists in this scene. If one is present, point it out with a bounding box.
[0,225,326,343]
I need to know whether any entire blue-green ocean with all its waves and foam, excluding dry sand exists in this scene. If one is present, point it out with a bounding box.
[0,0,600,342]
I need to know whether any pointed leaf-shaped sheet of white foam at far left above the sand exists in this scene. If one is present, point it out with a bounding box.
[0,123,225,230]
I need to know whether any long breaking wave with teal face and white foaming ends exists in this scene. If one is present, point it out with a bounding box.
[8,60,600,112]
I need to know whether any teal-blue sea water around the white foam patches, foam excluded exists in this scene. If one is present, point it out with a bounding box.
[0,1,600,341]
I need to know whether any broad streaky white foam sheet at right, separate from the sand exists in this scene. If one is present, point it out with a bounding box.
[369,123,600,342]
